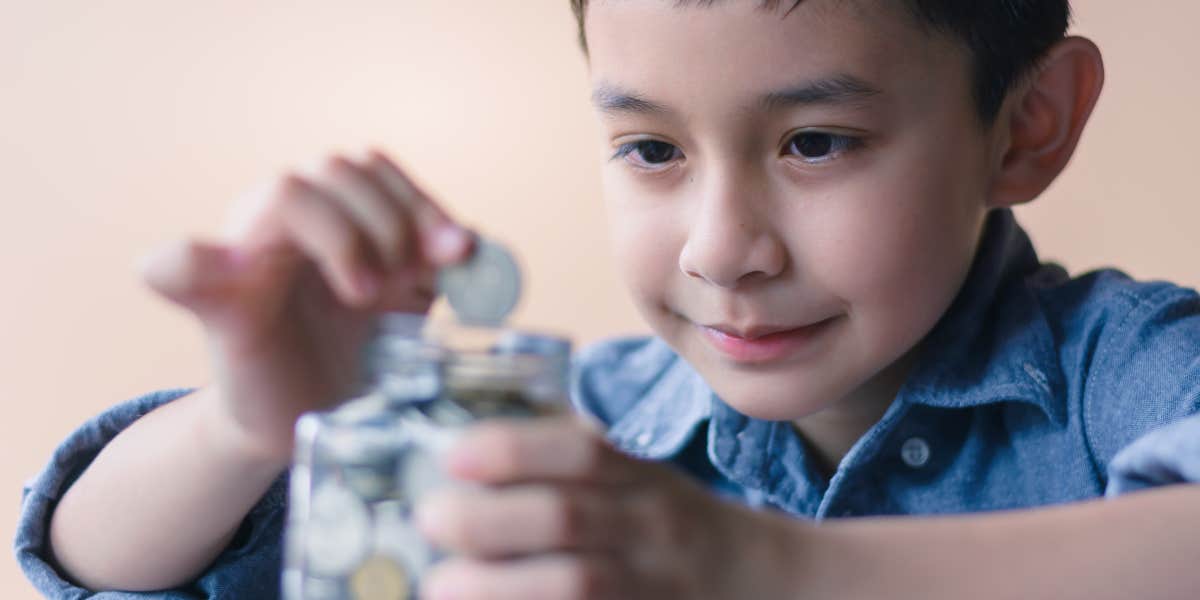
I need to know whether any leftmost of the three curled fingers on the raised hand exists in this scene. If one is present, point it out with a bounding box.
[275,175,380,306]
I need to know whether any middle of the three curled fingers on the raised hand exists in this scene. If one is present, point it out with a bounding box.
[317,156,419,268]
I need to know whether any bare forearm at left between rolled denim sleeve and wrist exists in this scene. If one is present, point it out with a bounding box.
[50,390,287,590]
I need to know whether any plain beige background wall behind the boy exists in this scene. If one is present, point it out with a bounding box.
[0,0,1200,599]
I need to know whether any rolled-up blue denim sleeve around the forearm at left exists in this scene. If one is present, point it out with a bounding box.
[14,389,287,600]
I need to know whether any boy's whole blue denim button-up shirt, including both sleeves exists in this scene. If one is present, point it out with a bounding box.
[17,210,1200,599]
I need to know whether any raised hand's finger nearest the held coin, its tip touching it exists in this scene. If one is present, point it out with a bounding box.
[364,150,474,265]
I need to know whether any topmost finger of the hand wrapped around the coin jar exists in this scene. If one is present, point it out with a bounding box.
[446,418,642,485]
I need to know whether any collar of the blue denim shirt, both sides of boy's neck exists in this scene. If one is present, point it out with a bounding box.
[608,209,1066,460]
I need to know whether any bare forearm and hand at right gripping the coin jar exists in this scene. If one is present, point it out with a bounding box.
[418,421,1200,600]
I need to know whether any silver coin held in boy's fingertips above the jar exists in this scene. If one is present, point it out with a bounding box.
[438,238,521,325]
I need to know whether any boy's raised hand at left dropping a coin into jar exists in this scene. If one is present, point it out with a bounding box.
[144,151,472,466]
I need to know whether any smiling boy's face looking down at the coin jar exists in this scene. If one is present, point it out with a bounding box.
[586,0,998,420]
